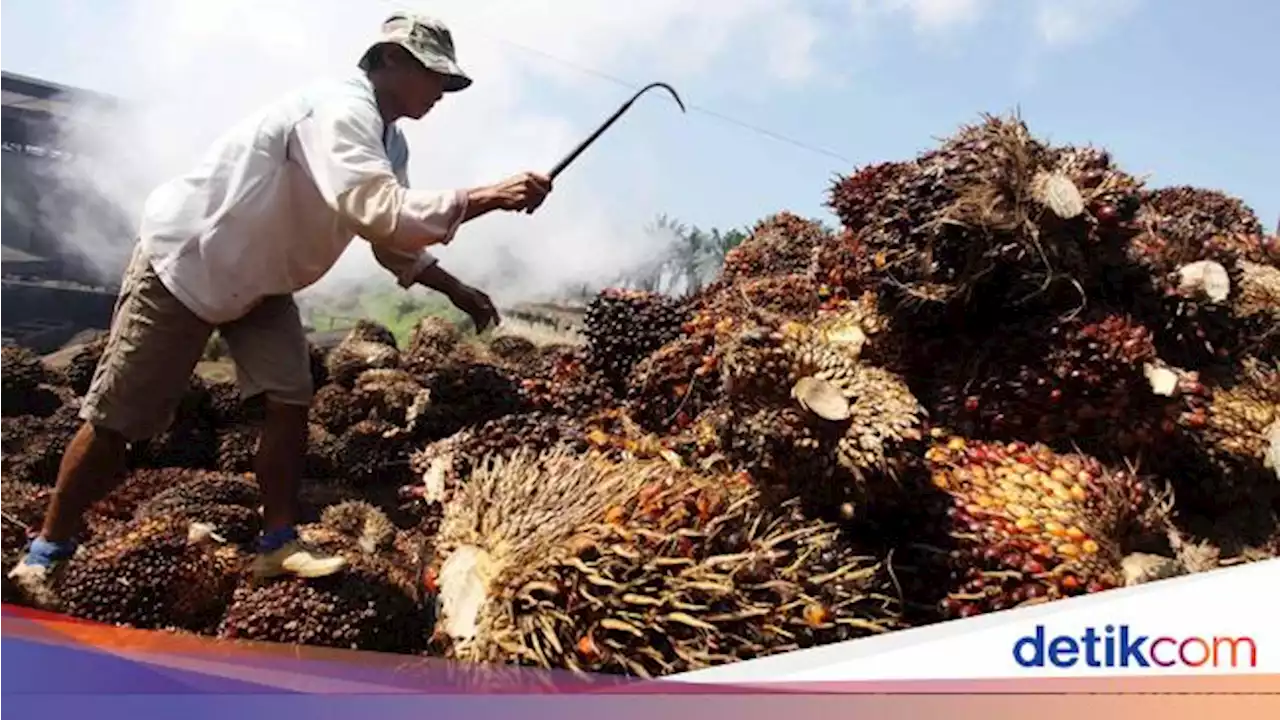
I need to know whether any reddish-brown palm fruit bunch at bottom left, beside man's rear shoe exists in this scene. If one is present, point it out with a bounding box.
[54,516,236,632]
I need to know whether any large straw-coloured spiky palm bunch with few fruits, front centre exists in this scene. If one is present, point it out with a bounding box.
[428,454,897,676]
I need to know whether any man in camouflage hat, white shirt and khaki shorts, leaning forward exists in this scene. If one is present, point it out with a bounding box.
[9,13,550,589]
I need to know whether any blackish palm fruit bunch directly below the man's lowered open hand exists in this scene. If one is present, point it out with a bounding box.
[413,364,526,441]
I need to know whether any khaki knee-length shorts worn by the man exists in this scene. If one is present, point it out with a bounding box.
[81,247,314,442]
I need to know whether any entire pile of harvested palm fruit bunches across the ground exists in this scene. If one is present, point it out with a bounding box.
[0,110,1280,676]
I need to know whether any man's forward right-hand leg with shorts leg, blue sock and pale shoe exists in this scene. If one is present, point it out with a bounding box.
[219,296,346,578]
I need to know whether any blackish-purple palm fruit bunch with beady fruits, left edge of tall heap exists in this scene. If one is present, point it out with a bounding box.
[582,288,687,395]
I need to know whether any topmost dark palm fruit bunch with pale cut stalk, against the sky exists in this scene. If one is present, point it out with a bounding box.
[829,117,1131,313]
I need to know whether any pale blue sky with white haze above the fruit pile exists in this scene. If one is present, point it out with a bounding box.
[0,0,1280,300]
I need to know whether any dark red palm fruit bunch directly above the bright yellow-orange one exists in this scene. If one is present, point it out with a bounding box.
[920,309,1179,452]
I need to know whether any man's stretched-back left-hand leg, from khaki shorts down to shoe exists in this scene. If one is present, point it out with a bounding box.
[10,250,212,582]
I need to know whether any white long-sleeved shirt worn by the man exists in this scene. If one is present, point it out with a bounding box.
[140,76,467,324]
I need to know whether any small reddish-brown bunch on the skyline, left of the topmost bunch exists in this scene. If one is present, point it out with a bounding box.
[712,211,831,291]
